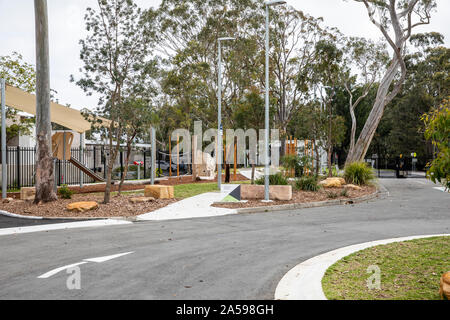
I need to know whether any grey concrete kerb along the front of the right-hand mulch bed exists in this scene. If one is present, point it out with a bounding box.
[227,185,389,214]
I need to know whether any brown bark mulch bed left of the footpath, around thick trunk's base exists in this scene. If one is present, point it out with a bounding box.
[0,194,177,218]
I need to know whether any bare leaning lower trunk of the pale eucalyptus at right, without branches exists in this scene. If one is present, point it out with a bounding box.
[346,59,401,164]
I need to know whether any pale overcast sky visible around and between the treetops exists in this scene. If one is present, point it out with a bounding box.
[0,0,450,109]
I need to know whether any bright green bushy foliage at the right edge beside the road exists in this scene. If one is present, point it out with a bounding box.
[422,100,450,189]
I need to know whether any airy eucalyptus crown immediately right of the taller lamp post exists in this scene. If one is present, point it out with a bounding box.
[271,6,333,150]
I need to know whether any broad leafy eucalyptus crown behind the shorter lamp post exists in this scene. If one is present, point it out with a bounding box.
[147,0,262,128]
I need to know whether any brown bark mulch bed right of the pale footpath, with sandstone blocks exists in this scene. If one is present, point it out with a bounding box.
[214,186,377,209]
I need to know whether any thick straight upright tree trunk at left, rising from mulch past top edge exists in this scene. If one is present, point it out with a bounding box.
[34,0,58,204]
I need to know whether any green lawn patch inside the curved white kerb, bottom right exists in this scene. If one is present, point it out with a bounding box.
[322,237,450,300]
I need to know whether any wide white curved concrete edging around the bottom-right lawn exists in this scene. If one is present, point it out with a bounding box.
[275,234,450,300]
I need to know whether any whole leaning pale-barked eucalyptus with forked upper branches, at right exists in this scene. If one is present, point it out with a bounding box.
[347,0,436,163]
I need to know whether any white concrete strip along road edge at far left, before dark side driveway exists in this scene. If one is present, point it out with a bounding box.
[0,220,132,236]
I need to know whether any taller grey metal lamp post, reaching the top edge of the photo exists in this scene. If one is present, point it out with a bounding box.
[264,0,286,202]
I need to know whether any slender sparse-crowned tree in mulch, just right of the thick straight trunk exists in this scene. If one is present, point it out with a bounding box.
[77,0,153,203]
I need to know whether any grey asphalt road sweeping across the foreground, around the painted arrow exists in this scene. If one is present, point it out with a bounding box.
[0,179,450,300]
